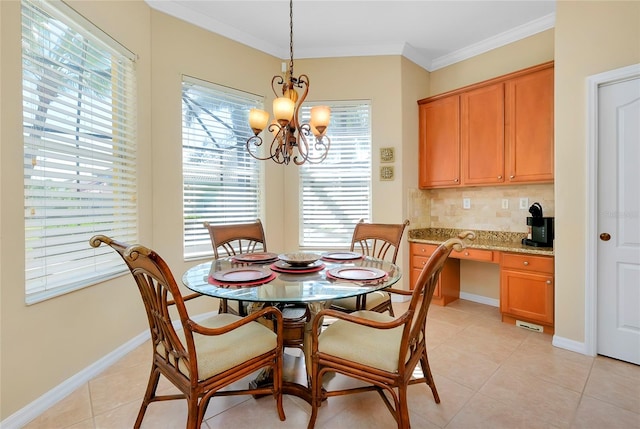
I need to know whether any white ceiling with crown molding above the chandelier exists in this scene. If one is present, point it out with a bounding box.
[146,0,555,71]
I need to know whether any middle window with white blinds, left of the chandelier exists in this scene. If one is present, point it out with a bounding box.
[182,76,263,259]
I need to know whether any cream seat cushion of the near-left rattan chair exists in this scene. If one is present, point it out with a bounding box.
[178,313,278,380]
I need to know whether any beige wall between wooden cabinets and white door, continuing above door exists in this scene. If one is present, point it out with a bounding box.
[555,1,640,342]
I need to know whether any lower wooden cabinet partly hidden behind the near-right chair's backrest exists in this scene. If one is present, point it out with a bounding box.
[409,243,460,305]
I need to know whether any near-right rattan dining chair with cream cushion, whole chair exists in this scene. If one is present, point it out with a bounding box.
[308,231,475,429]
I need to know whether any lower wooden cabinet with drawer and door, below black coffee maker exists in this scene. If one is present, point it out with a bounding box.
[500,253,554,332]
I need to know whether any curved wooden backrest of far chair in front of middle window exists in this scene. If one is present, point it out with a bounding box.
[204,219,267,259]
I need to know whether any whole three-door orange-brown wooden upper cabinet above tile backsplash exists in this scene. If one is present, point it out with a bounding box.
[418,62,553,189]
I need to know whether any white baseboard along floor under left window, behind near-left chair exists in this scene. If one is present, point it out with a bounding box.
[0,312,217,429]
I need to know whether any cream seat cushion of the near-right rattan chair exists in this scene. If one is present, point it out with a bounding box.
[318,310,403,372]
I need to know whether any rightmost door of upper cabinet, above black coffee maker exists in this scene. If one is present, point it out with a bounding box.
[505,68,553,183]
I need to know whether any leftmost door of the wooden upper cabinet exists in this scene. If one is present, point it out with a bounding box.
[418,95,460,188]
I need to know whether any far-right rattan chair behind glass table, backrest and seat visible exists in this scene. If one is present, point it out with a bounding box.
[331,219,409,316]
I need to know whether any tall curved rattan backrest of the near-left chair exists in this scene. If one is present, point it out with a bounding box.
[89,235,198,383]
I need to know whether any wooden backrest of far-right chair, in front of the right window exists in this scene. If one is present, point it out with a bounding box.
[351,219,409,264]
